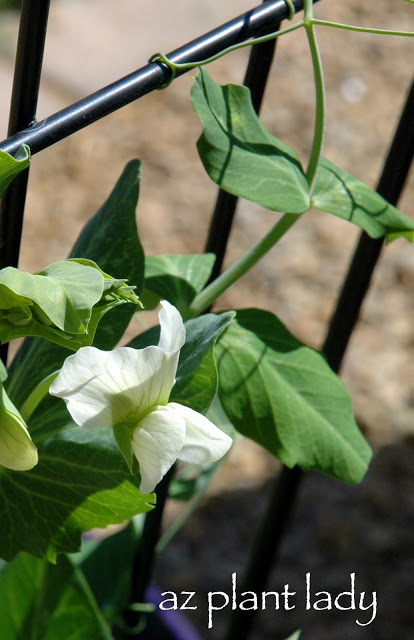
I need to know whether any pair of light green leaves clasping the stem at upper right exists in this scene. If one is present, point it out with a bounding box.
[192,69,414,241]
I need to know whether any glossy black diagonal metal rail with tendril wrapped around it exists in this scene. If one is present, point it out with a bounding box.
[0,0,316,154]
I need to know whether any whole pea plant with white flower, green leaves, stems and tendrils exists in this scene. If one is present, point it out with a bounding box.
[0,0,414,640]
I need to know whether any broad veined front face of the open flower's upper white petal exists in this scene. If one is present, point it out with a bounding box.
[49,347,178,429]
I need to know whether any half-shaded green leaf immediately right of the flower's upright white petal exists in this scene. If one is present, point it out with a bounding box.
[128,311,234,413]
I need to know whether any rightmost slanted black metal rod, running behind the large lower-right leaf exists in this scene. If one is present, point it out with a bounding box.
[225,74,414,640]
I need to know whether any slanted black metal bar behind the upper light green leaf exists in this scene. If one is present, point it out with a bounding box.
[205,11,280,282]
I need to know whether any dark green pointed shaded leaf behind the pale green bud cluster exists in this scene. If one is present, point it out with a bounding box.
[7,160,144,407]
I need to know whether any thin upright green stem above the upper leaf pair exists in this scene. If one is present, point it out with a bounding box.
[305,14,325,194]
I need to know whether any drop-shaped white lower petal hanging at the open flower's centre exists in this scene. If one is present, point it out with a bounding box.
[132,405,186,493]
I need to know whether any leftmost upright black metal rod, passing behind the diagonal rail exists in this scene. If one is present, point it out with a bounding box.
[0,0,50,362]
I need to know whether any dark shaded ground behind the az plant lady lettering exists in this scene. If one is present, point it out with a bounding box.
[156,442,414,640]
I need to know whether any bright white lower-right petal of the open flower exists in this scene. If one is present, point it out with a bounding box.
[168,402,233,464]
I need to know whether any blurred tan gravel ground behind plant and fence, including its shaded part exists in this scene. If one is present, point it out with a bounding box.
[0,0,414,640]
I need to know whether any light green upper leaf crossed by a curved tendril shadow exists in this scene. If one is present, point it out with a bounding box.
[191,69,309,214]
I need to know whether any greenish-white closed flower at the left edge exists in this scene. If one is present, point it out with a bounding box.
[0,406,38,471]
